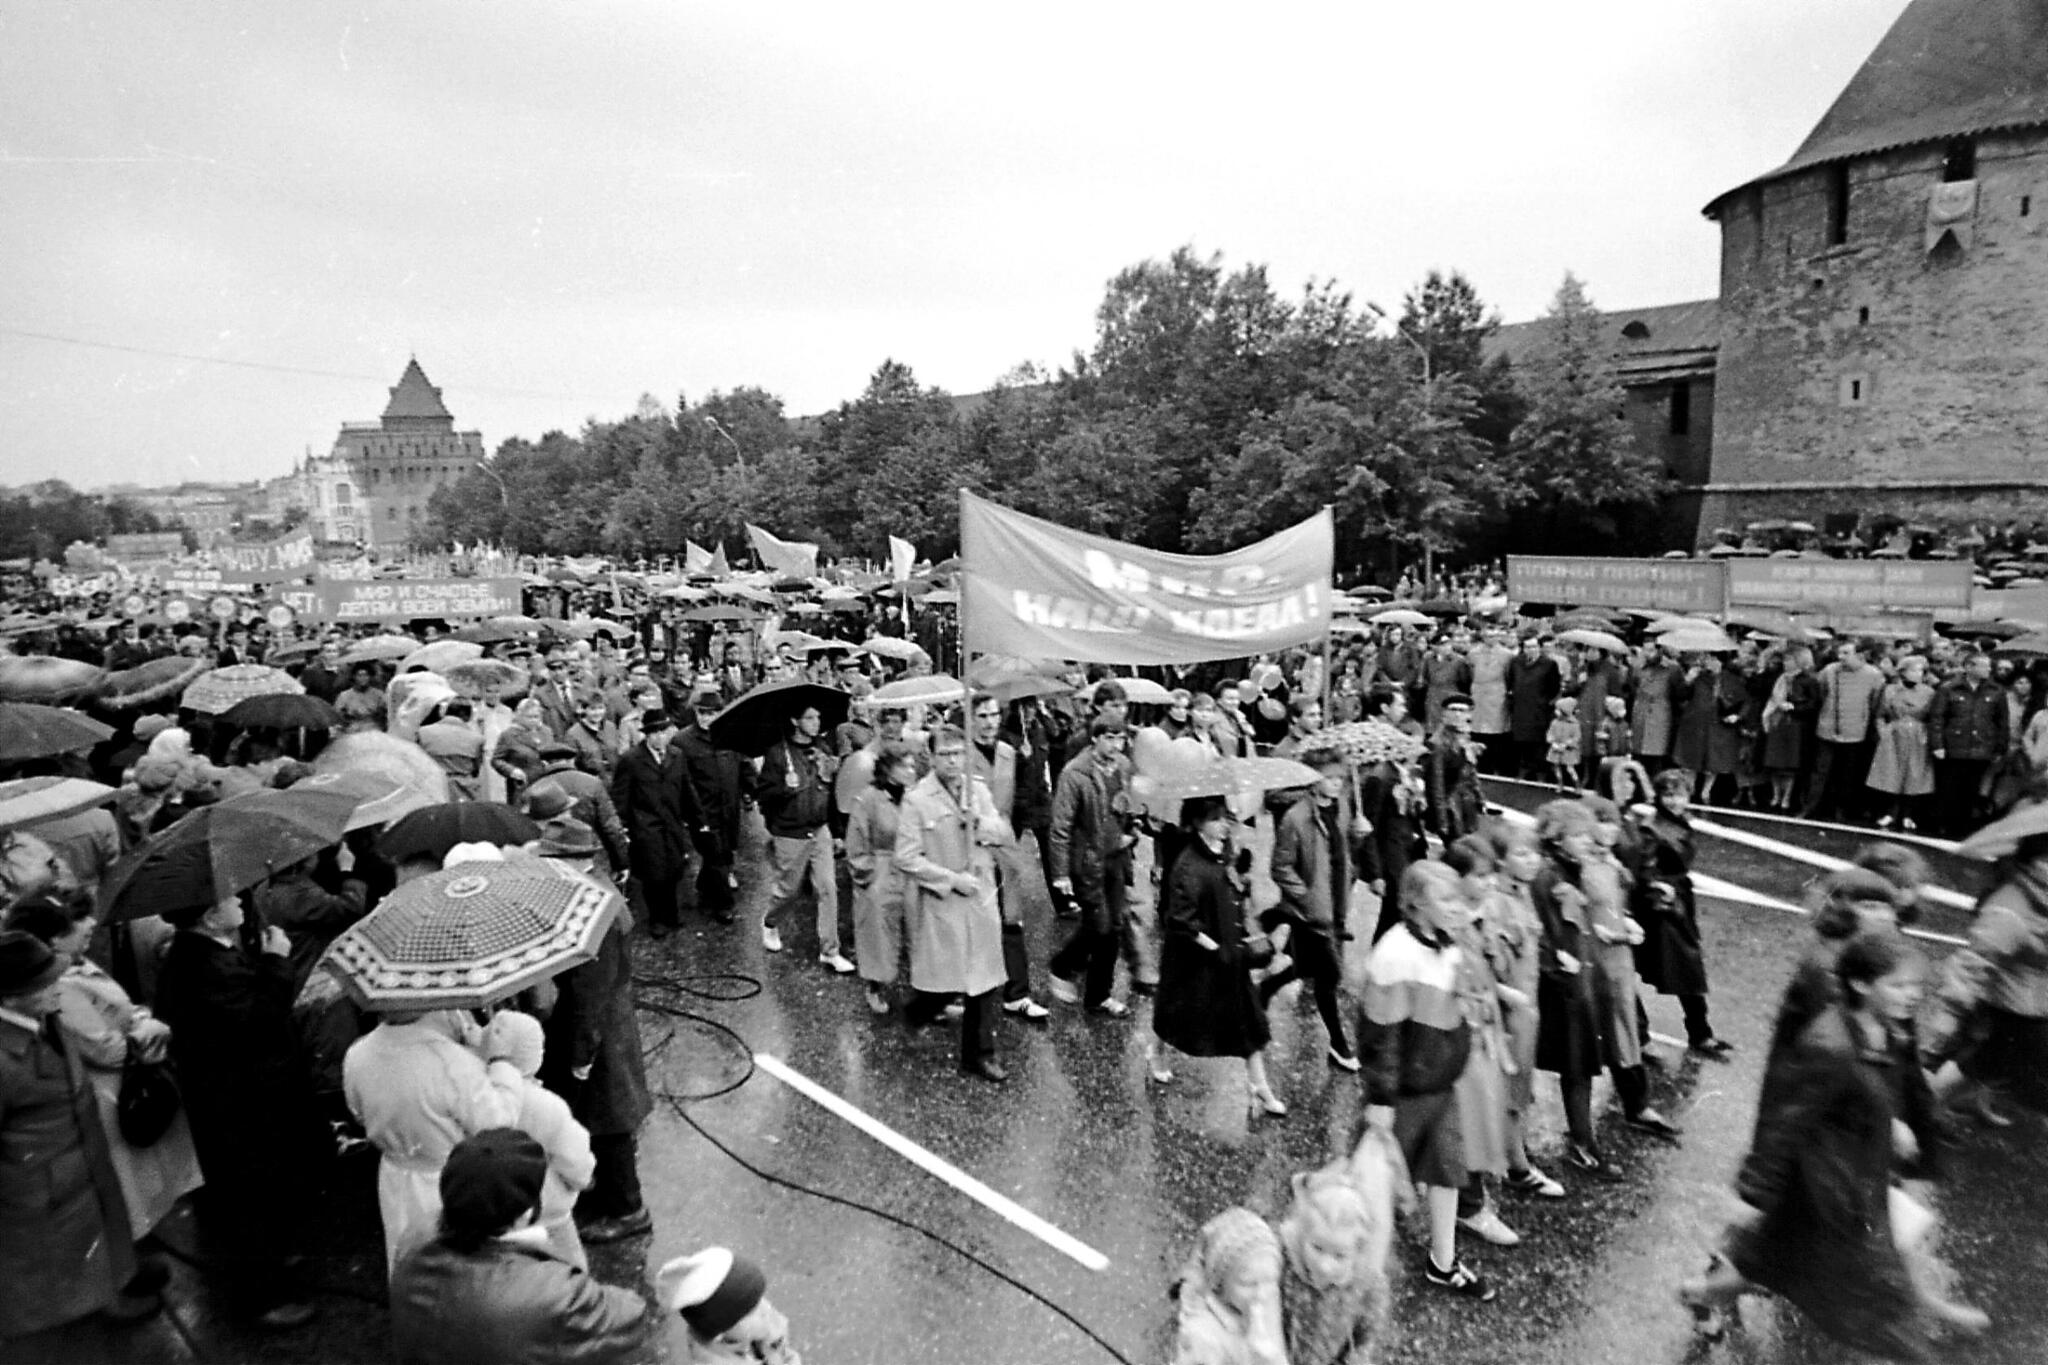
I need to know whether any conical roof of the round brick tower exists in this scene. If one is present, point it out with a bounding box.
[1706,0,2048,215]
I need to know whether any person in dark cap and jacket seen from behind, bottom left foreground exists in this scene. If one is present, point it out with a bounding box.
[391,1128,649,1365]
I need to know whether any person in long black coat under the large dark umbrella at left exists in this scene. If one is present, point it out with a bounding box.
[156,898,334,1328]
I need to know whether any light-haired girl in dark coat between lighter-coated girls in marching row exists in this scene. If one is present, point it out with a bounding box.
[1530,800,1620,1181]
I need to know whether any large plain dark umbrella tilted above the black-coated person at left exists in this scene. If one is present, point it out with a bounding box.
[100,788,356,921]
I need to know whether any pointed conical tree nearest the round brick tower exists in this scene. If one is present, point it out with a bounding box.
[1509,274,1665,544]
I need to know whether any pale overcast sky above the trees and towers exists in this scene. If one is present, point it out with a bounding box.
[0,0,1905,487]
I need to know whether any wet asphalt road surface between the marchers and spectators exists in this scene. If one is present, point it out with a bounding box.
[39,786,2048,1365]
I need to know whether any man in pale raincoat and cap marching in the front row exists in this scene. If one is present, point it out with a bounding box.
[895,724,1014,1083]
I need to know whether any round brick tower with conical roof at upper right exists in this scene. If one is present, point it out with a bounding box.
[1702,0,2048,526]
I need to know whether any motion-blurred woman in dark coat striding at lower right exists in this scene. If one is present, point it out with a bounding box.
[1679,929,1987,1361]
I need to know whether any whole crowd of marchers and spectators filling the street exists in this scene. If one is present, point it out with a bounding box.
[0,589,2048,1365]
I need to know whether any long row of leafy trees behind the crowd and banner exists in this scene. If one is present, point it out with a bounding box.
[428,248,1665,571]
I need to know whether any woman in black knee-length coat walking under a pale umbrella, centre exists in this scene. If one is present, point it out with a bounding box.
[1151,798,1272,1097]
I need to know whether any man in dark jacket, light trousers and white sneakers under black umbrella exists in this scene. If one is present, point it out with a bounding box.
[754,706,854,976]
